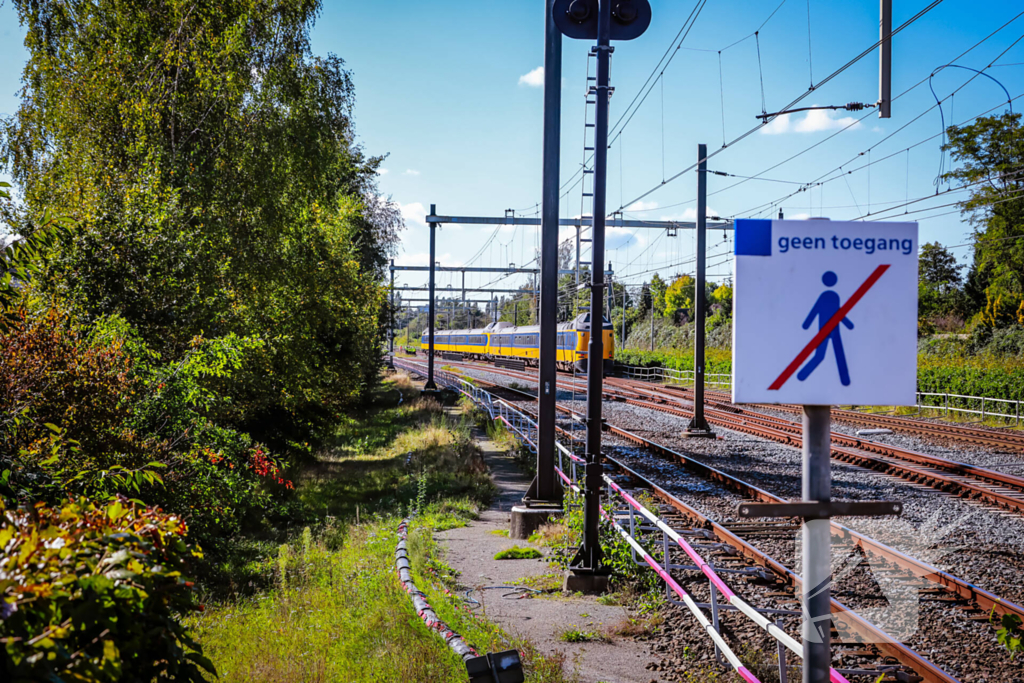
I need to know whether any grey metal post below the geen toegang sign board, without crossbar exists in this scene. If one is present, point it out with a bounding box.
[803,405,831,683]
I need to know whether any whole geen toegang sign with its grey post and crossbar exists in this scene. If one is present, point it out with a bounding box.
[732,219,919,683]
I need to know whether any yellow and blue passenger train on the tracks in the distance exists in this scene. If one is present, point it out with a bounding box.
[420,313,615,375]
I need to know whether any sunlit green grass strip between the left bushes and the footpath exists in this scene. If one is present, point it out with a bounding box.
[188,382,567,683]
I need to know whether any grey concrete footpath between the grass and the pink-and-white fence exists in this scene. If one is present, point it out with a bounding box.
[435,421,660,683]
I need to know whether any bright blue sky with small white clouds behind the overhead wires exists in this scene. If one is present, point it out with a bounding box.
[0,0,1024,296]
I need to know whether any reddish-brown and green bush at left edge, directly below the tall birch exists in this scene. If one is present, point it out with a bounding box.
[0,310,291,549]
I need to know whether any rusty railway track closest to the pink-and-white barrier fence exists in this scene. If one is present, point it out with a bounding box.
[393,360,1024,683]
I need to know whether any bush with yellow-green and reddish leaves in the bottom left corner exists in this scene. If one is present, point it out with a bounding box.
[0,500,213,681]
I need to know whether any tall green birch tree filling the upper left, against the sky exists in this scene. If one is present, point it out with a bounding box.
[0,0,400,435]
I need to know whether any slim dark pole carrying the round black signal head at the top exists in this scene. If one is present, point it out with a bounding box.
[570,0,611,574]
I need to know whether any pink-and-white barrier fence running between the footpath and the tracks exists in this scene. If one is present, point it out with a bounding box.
[394,359,878,683]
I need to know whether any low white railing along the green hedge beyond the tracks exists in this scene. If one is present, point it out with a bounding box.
[615,364,1021,426]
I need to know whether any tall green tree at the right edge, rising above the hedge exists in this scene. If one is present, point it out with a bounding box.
[943,114,1024,324]
